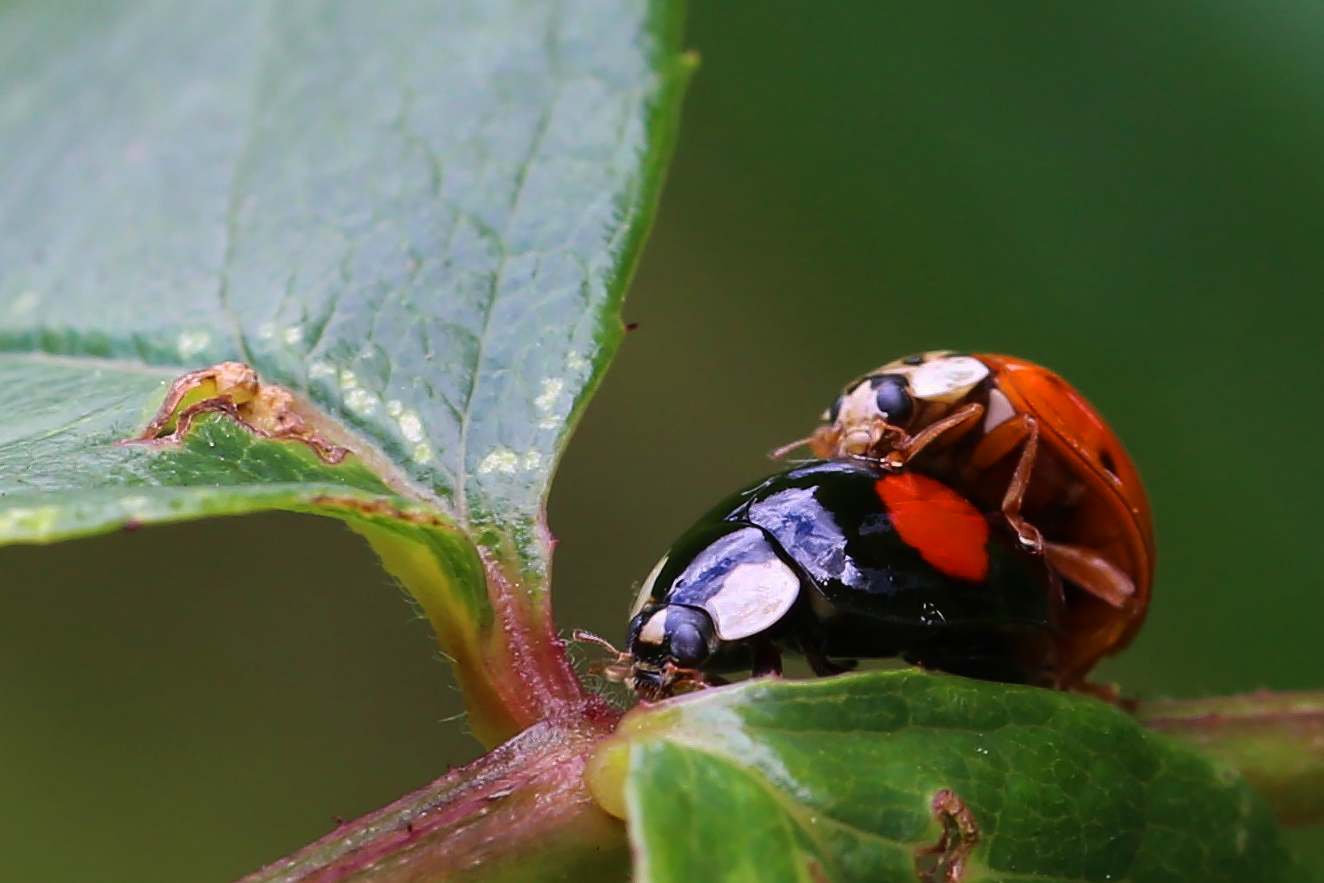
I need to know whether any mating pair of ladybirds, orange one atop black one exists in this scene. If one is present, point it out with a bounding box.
[609,352,1155,699]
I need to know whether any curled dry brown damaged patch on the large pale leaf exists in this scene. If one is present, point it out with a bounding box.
[122,361,350,465]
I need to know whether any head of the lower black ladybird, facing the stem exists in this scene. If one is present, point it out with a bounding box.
[628,604,718,699]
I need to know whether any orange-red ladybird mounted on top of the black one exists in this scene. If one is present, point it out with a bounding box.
[784,351,1155,691]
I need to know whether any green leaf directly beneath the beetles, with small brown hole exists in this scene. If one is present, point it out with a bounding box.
[589,670,1305,883]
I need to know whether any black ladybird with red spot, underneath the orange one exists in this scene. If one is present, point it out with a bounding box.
[609,459,1061,700]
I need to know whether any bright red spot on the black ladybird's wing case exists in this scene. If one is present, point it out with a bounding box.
[875,473,989,582]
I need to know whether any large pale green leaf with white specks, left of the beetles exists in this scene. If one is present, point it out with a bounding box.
[0,0,690,740]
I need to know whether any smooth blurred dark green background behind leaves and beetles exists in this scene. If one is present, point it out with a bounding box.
[0,0,1324,883]
